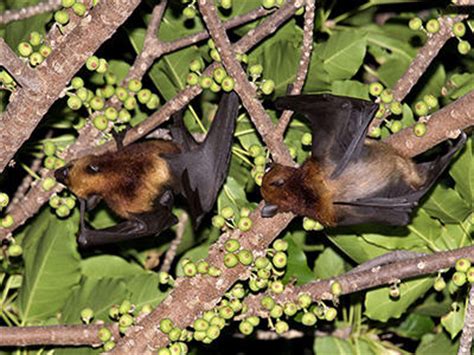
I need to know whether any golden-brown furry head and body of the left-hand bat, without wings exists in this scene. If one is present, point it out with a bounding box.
[66,140,179,218]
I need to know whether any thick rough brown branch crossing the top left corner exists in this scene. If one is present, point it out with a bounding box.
[0,0,140,171]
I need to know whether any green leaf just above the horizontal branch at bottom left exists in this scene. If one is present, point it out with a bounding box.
[62,277,130,324]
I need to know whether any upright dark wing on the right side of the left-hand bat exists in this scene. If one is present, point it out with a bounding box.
[167,92,239,226]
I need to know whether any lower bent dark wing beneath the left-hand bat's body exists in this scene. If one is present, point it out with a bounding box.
[77,190,178,249]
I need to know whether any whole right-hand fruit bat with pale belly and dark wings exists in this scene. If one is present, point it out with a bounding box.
[261,94,466,226]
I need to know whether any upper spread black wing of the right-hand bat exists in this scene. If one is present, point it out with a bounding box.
[275,94,378,179]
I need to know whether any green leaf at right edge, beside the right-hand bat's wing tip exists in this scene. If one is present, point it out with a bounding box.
[449,138,474,212]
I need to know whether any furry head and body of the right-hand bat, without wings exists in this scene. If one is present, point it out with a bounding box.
[261,140,426,226]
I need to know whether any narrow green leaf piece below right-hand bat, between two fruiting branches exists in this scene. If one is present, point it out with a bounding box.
[283,233,314,285]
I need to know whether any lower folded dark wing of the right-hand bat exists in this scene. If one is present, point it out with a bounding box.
[335,132,466,225]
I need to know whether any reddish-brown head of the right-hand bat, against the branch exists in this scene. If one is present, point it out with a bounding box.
[260,164,297,217]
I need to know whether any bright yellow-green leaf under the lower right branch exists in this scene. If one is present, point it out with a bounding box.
[365,278,433,322]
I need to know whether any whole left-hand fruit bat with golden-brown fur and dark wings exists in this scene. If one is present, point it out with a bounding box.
[54,93,239,247]
